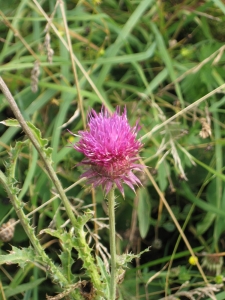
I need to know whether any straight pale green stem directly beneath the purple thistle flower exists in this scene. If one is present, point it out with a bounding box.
[108,187,116,300]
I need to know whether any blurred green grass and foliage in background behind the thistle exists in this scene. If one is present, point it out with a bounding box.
[0,0,225,300]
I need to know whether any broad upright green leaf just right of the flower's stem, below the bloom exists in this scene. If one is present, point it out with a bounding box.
[138,188,151,239]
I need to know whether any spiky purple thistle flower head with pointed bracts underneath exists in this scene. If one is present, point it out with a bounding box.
[73,107,142,196]
